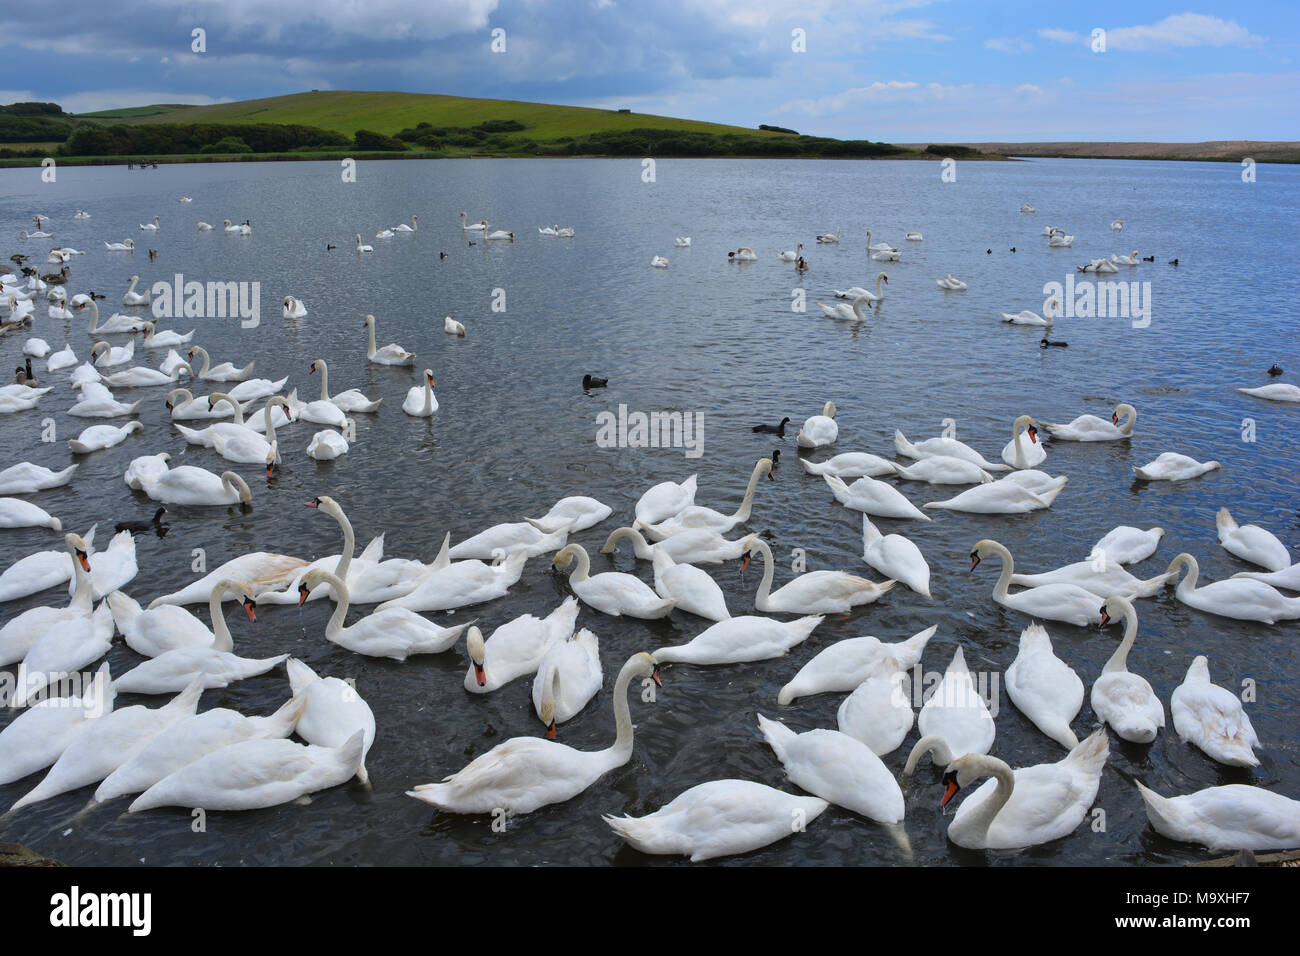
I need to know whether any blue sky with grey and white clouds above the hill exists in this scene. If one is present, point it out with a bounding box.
[0,0,1300,143]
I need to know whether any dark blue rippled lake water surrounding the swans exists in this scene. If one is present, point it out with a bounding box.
[0,160,1300,865]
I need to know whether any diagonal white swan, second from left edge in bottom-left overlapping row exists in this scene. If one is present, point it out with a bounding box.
[10,680,203,813]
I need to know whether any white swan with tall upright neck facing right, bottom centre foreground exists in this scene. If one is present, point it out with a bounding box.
[407,653,660,827]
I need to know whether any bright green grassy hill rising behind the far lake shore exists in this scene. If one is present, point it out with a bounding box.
[85,90,785,140]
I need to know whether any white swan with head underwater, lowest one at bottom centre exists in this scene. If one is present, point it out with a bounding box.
[601,780,829,864]
